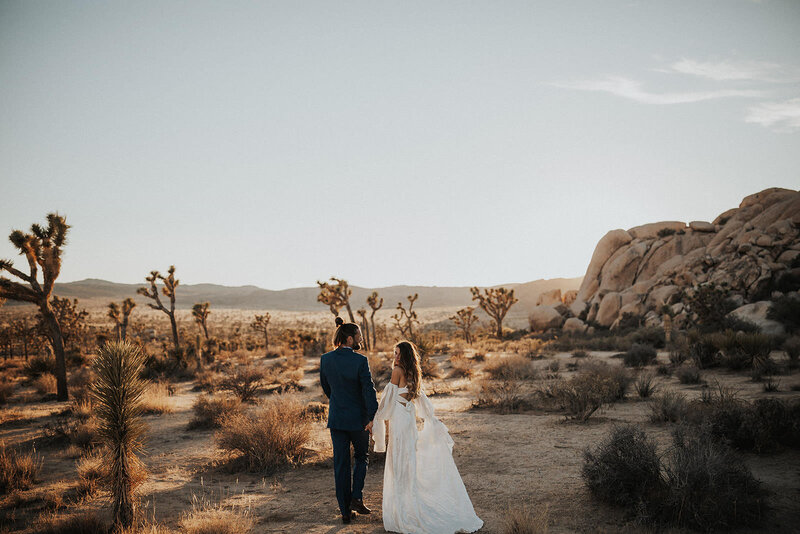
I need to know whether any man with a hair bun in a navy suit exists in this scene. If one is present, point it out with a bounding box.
[319,317,378,523]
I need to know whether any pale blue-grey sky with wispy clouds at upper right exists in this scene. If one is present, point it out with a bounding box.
[0,0,800,289]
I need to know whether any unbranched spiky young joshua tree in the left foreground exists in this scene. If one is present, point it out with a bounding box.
[91,341,147,529]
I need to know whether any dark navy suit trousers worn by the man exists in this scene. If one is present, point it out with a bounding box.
[330,428,369,516]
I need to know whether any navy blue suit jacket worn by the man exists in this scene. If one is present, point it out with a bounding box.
[319,347,378,430]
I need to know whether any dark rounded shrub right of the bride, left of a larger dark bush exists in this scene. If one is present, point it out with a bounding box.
[581,425,663,506]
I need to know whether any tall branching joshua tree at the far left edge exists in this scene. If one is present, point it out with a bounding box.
[0,213,69,401]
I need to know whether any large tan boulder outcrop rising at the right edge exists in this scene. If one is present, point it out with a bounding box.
[568,188,800,329]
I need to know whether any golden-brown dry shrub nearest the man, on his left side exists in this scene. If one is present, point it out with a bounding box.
[216,395,311,472]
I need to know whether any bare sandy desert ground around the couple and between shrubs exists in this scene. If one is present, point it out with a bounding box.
[0,352,800,534]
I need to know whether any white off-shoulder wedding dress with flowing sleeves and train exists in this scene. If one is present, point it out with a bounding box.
[372,383,483,534]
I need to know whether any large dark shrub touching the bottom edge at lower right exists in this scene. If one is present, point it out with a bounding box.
[660,433,765,531]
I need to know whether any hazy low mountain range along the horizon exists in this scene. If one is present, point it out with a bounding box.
[6,278,582,311]
